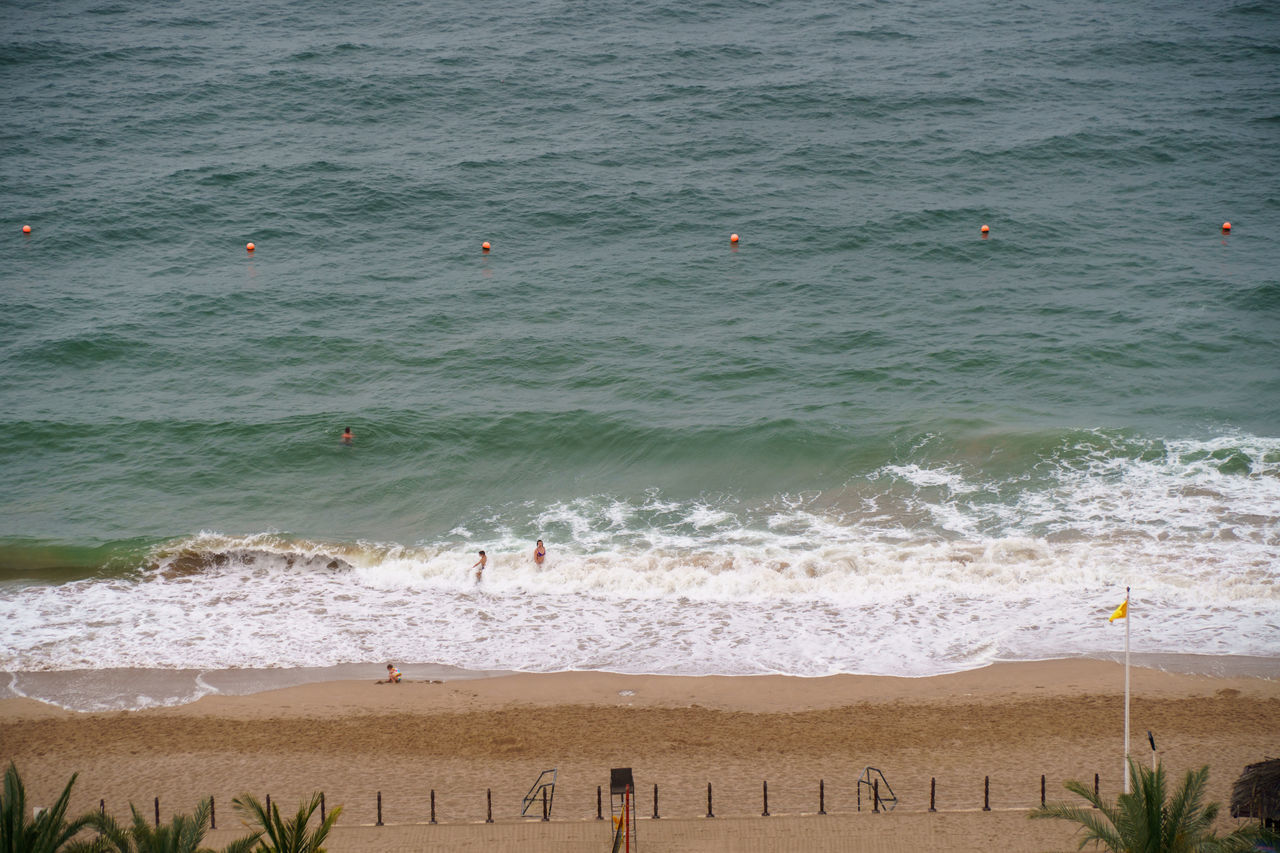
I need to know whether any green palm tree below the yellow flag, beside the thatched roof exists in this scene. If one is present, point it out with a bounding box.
[1030,758,1280,853]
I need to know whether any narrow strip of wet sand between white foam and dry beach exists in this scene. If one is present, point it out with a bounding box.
[0,653,1280,713]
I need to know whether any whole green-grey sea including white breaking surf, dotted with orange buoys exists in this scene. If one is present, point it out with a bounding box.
[0,0,1280,708]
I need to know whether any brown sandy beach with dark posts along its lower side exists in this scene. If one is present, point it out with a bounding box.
[0,660,1280,853]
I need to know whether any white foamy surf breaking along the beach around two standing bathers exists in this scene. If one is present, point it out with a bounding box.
[0,432,1280,702]
